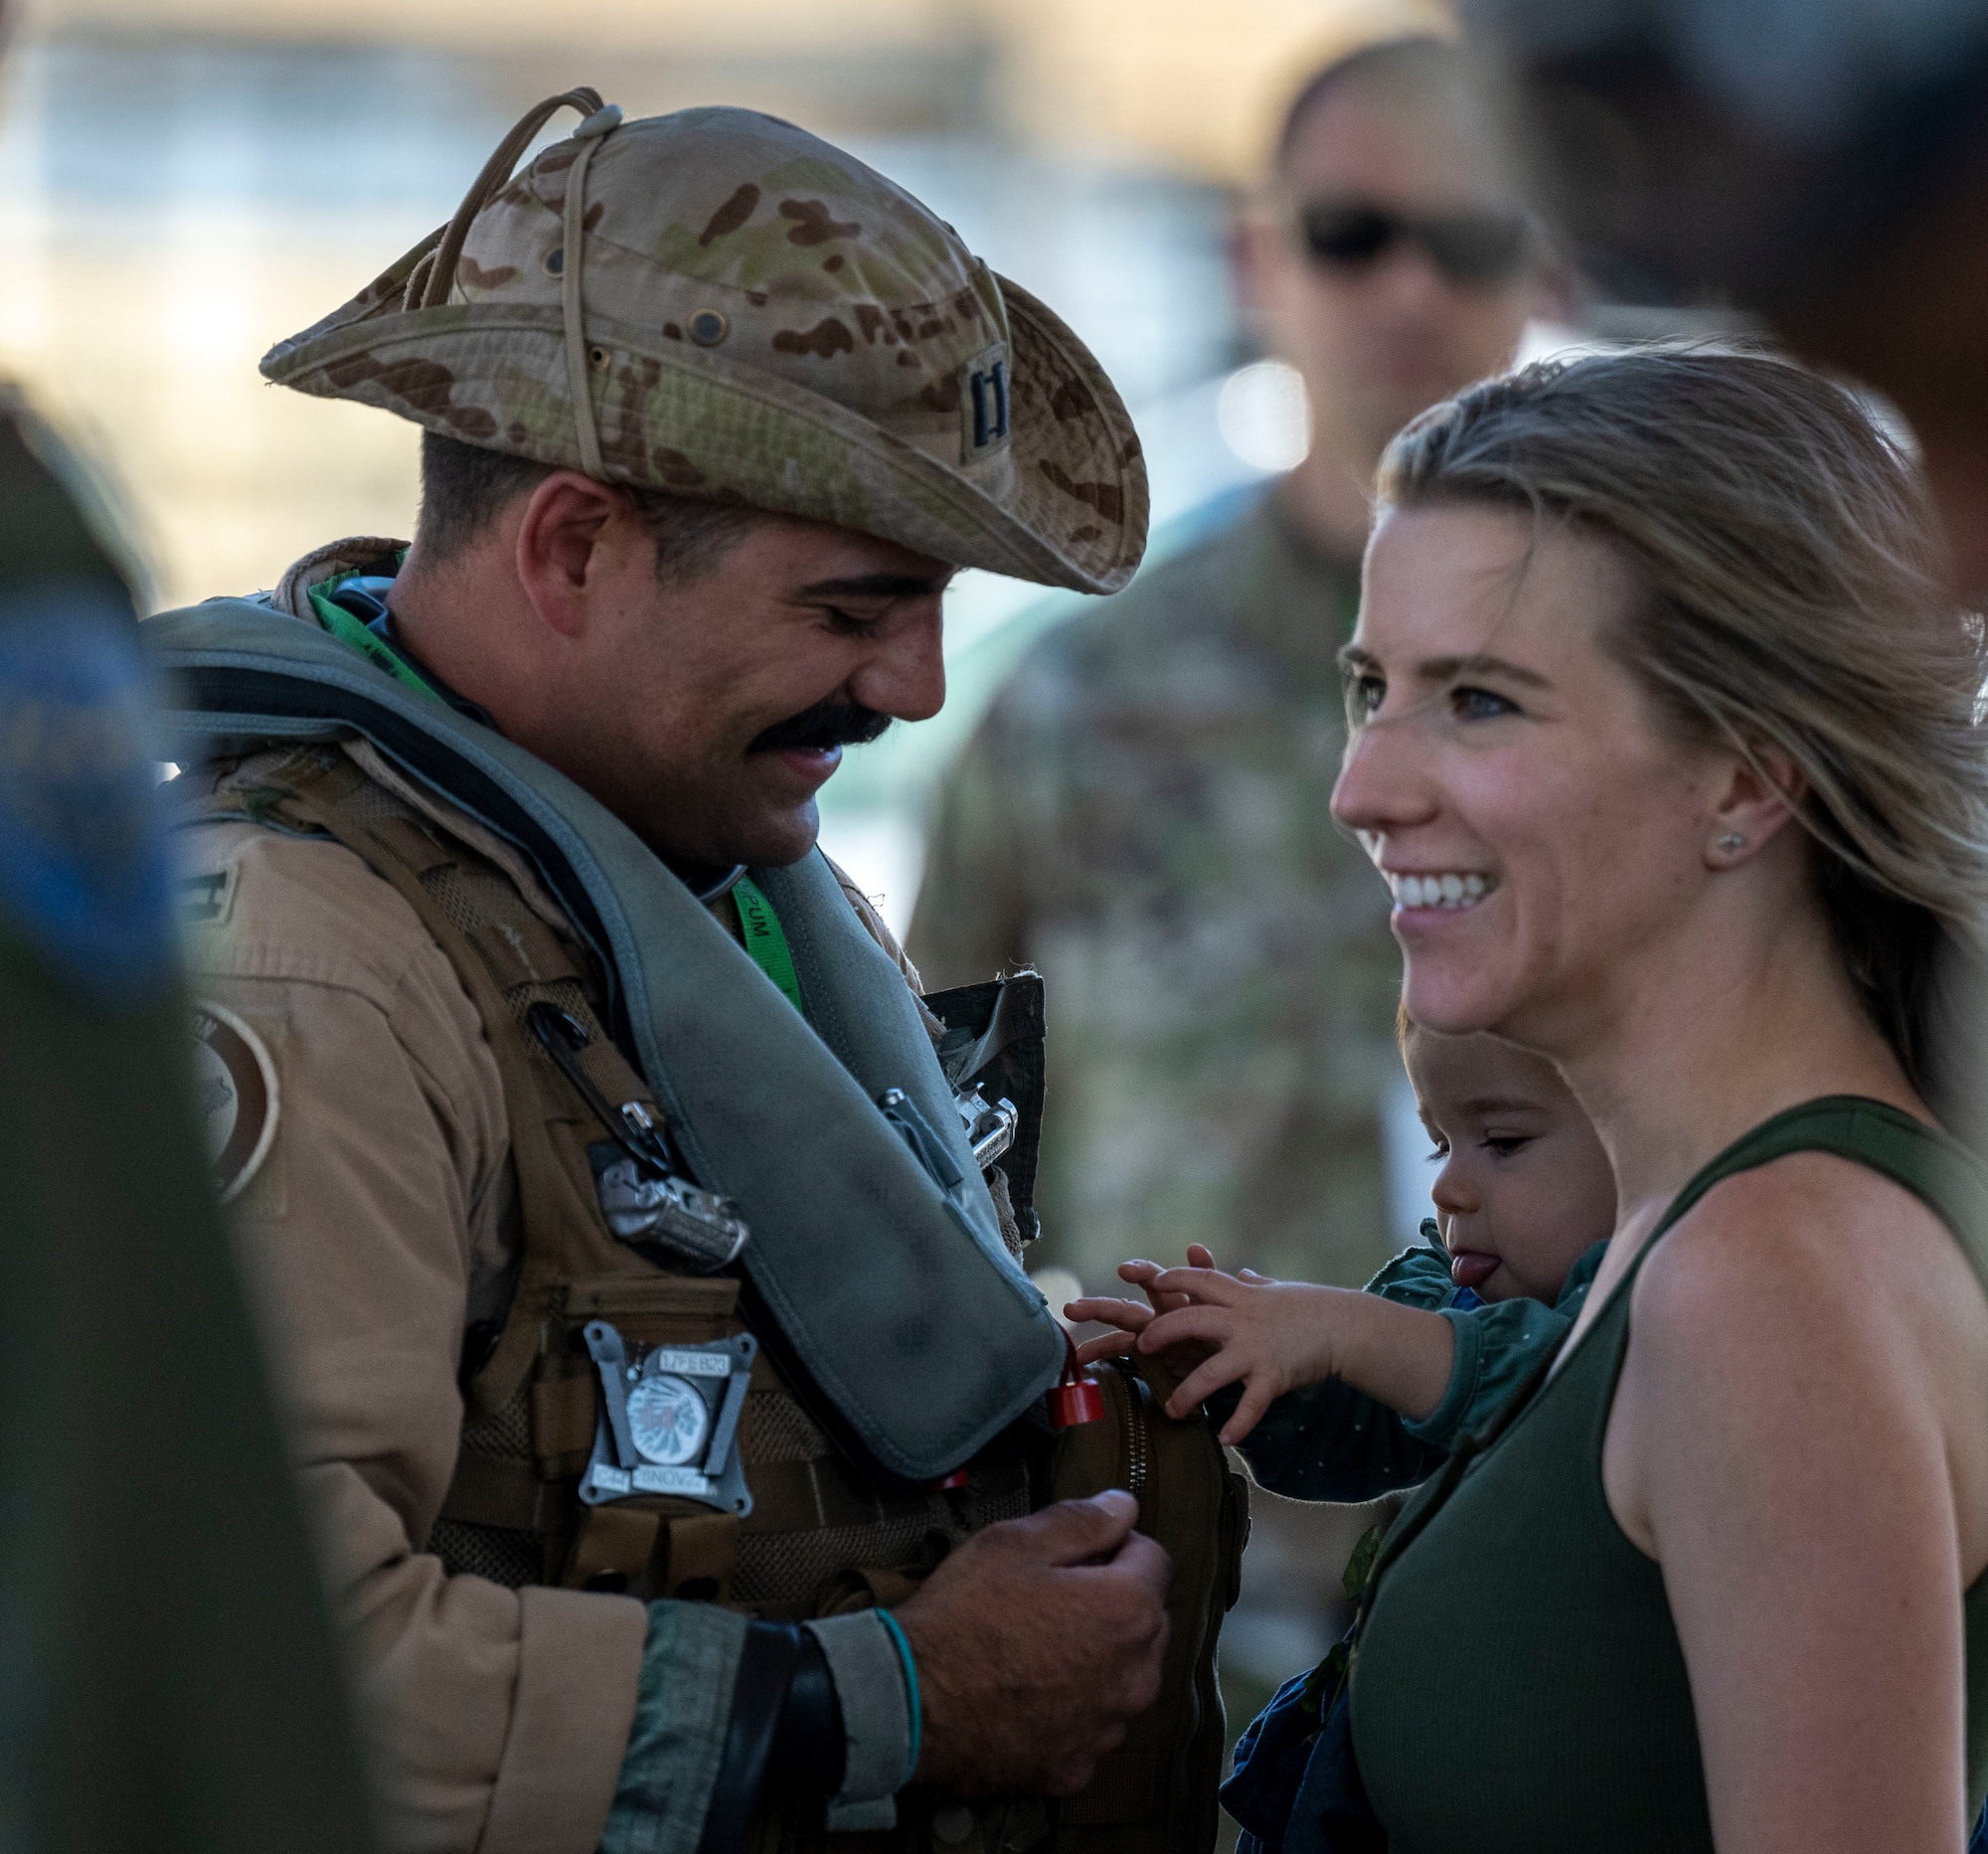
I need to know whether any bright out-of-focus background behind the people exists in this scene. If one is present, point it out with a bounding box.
[0,0,1598,1773]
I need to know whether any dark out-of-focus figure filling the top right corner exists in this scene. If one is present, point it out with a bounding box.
[1467,0,1988,598]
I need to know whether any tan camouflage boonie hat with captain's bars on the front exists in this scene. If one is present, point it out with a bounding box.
[262,89,1147,592]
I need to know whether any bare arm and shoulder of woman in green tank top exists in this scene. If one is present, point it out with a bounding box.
[1602,1154,1988,1854]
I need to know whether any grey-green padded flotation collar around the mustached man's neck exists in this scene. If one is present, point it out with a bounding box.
[147,600,1064,1484]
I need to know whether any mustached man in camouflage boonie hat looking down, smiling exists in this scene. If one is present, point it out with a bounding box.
[151,89,1241,1854]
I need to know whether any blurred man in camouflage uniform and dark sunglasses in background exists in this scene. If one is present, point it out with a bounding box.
[909,36,1547,1289]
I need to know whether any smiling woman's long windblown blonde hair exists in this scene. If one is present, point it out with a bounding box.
[1380,350,1988,1098]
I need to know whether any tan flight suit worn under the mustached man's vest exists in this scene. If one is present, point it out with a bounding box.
[181,549,916,1854]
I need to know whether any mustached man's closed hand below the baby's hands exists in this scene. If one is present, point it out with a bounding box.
[897,1492,1169,1796]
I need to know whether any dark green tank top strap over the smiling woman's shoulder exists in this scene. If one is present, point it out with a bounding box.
[1616,1095,1988,1299]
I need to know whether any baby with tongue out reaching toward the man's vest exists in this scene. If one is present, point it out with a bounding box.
[1066,1015,1614,1854]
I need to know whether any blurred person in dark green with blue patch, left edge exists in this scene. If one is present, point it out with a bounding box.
[0,308,368,1854]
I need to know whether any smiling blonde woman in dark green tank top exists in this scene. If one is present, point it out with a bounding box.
[1328,354,1988,1854]
